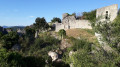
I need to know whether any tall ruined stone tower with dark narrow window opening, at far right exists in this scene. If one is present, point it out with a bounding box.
[96,4,118,21]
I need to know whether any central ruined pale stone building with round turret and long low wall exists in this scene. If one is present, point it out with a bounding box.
[55,13,92,32]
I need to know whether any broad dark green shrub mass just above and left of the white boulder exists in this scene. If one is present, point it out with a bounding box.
[27,35,60,59]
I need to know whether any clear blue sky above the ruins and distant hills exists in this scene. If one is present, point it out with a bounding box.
[0,0,120,26]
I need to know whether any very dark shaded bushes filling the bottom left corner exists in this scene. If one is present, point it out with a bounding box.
[0,49,45,67]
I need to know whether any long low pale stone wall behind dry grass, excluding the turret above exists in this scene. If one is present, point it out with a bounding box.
[55,20,92,32]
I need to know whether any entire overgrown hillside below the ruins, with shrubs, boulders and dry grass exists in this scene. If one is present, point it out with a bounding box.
[0,11,120,67]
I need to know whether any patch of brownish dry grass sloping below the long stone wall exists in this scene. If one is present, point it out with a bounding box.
[66,29,97,43]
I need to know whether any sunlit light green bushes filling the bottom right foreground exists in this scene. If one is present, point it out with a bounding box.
[62,38,120,67]
